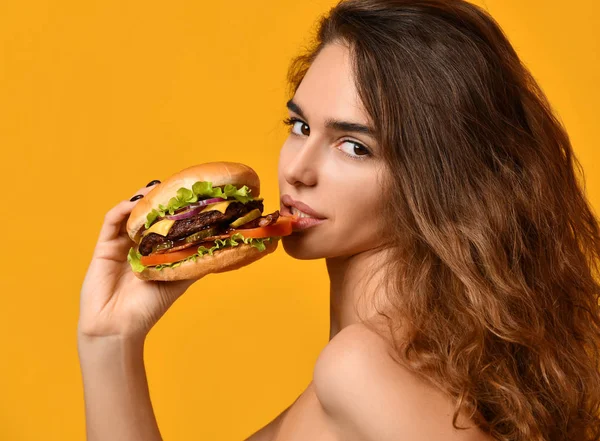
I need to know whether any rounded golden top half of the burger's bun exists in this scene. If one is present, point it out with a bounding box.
[127,162,260,242]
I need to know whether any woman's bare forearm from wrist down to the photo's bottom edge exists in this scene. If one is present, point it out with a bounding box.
[78,335,162,441]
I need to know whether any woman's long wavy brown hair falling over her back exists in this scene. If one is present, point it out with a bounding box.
[288,0,600,441]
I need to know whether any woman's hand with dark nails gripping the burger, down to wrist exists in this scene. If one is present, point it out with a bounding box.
[78,181,195,339]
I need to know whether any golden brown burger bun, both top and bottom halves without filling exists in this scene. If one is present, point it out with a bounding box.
[127,162,278,281]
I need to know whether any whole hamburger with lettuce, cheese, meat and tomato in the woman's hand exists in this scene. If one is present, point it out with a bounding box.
[127,162,292,281]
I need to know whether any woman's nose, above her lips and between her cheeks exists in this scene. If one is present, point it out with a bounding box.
[283,138,322,187]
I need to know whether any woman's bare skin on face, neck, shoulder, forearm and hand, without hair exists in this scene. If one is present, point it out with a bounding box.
[78,44,490,441]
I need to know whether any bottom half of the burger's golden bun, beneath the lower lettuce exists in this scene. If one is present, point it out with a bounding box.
[134,237,279,281]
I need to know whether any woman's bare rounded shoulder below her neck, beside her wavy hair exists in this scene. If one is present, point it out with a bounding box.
[313,324,491,441]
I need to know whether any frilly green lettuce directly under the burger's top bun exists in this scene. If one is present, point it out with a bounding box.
[145,181,253,228]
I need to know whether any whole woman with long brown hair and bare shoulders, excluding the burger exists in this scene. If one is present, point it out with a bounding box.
[78,0,600,441]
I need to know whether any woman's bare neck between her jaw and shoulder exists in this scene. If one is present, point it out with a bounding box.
[326,249,392,340]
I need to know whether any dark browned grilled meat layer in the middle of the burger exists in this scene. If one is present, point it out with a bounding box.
[139,200,264,256]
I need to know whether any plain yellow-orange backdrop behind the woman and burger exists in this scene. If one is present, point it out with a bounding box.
[0,0,600,441]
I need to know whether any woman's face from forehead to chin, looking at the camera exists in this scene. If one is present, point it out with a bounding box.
[279,44,385,259]
